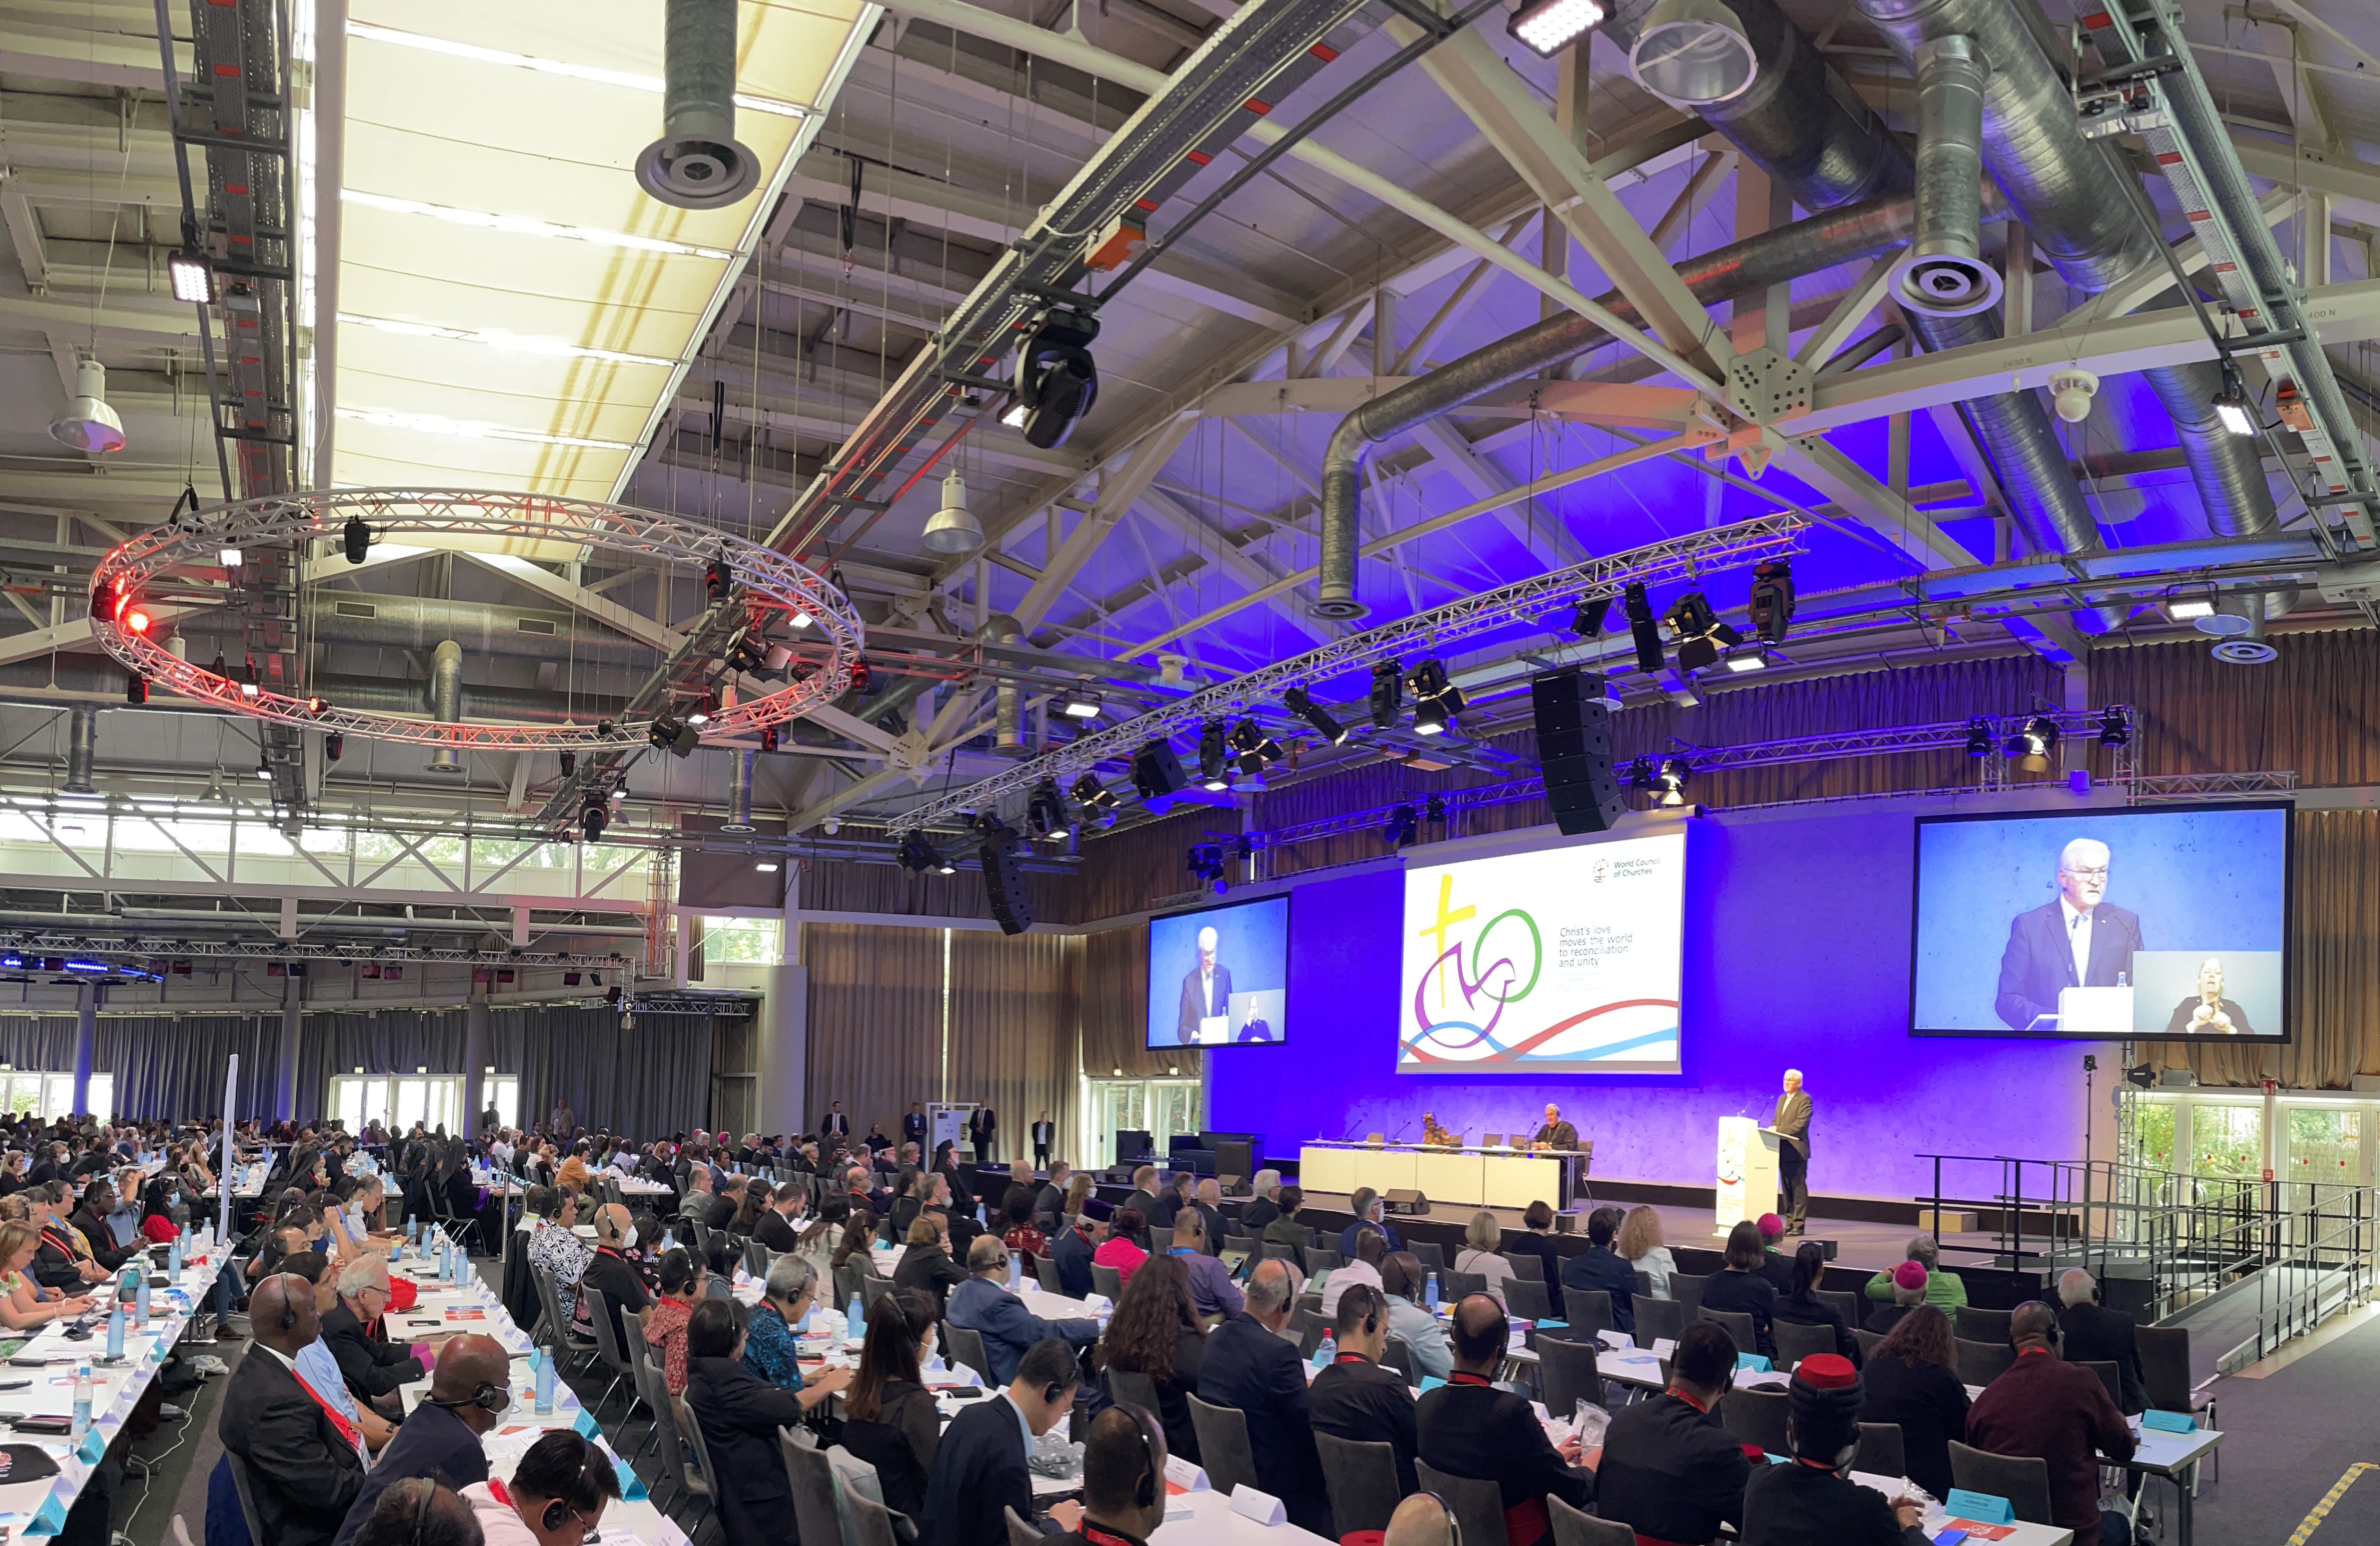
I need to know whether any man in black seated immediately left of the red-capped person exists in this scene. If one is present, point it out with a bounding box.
[1595,1320,1751,1541]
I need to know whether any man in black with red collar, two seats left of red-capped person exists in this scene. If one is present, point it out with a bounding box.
[1409,1294,1595,1546]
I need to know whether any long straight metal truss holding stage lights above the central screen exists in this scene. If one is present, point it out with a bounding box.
[888,514,1809,837]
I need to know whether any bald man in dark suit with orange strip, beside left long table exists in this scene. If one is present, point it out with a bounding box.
[214,1277,364,1546]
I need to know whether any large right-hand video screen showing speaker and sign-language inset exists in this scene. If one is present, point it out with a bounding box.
[1909,804,2290,1042]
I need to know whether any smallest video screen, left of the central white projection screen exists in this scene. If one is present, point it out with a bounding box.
[1147,897,1290,1046]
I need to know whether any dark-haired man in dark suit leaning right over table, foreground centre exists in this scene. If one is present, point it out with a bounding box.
[918,1339,1090,1546]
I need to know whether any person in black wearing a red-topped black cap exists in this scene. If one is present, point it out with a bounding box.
[1742,1353,1928,1546]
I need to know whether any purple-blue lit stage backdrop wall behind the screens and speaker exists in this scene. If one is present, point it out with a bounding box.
[1207,806,2121,1199]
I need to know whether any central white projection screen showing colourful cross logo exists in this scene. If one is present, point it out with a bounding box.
[1397,832,1685,1075]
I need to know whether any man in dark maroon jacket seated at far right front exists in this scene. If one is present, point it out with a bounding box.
[1966,1299,2135,1546]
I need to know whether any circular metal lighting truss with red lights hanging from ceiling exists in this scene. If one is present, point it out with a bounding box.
[90,488,866,751]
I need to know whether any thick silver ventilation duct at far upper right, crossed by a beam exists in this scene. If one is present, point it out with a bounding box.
[1859,0,2277,535]
